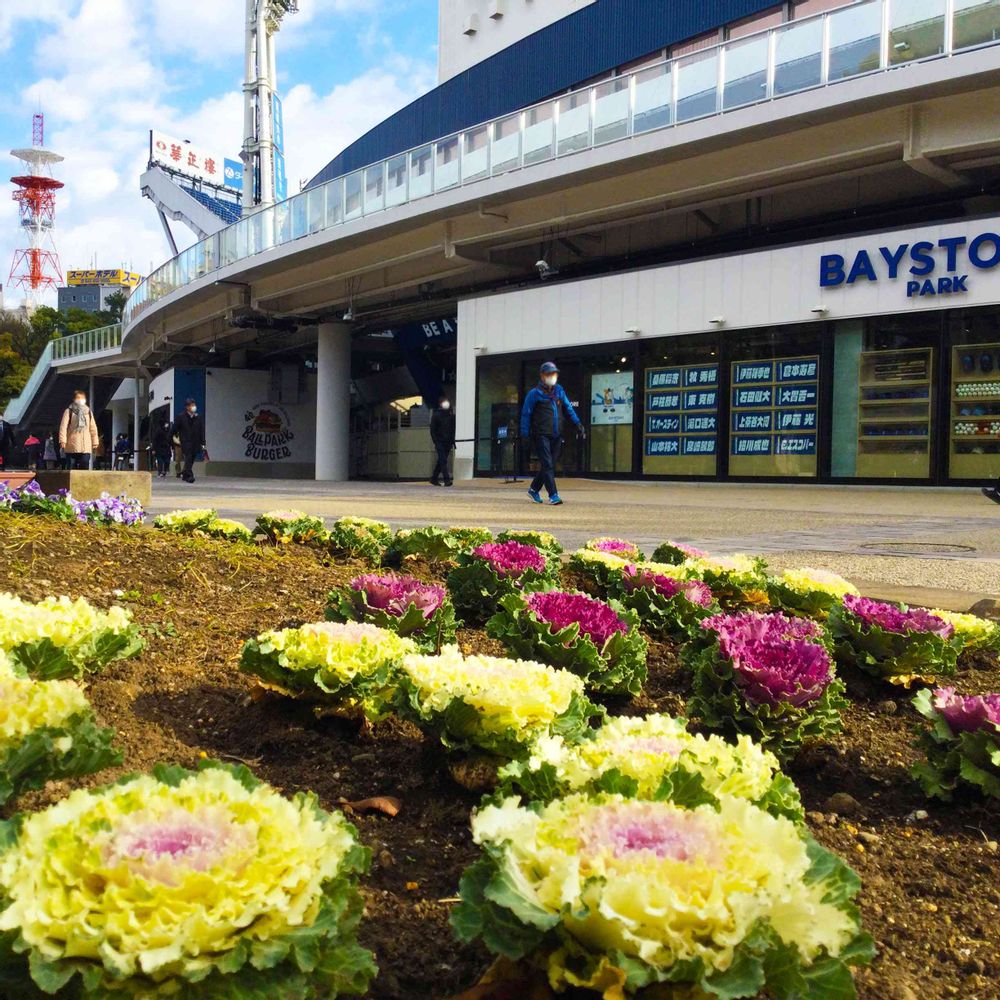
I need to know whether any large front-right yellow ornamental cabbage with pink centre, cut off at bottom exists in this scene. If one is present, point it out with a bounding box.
[452,795,873,1000]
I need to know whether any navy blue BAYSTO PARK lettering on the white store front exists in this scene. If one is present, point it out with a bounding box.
[819,233,1000,299]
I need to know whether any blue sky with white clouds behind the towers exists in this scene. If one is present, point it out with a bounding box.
[0,0,437,308]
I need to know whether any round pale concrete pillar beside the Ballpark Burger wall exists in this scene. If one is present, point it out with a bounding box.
[316,323,351,483]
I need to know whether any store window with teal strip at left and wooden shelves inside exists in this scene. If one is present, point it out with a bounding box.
[831,315,941,479]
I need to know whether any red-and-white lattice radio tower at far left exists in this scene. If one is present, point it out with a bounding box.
[9,114,63,312]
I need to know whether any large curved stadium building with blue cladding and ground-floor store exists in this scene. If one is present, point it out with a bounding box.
[7,0,1000,485]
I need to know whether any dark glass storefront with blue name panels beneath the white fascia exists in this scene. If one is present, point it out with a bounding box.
[476,306,1000,485]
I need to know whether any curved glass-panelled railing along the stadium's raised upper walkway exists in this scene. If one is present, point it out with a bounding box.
[111,0,1000,336]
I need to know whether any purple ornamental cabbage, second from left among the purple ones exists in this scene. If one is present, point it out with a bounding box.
[448,542,555,625]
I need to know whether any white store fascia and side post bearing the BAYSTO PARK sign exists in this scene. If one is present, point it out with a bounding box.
[456,217,1000,477]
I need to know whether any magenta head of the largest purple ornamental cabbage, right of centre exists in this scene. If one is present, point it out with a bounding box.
[731,639,833,707]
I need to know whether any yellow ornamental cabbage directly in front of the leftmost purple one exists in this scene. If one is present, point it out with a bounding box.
[240,622,417,720]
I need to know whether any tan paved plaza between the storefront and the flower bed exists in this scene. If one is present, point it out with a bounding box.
[152,478,1000,610]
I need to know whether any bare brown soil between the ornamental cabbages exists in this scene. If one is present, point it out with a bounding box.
[0,514,1000,1000]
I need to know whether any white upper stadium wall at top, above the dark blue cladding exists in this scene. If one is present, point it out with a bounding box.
[438,0,594,83]
